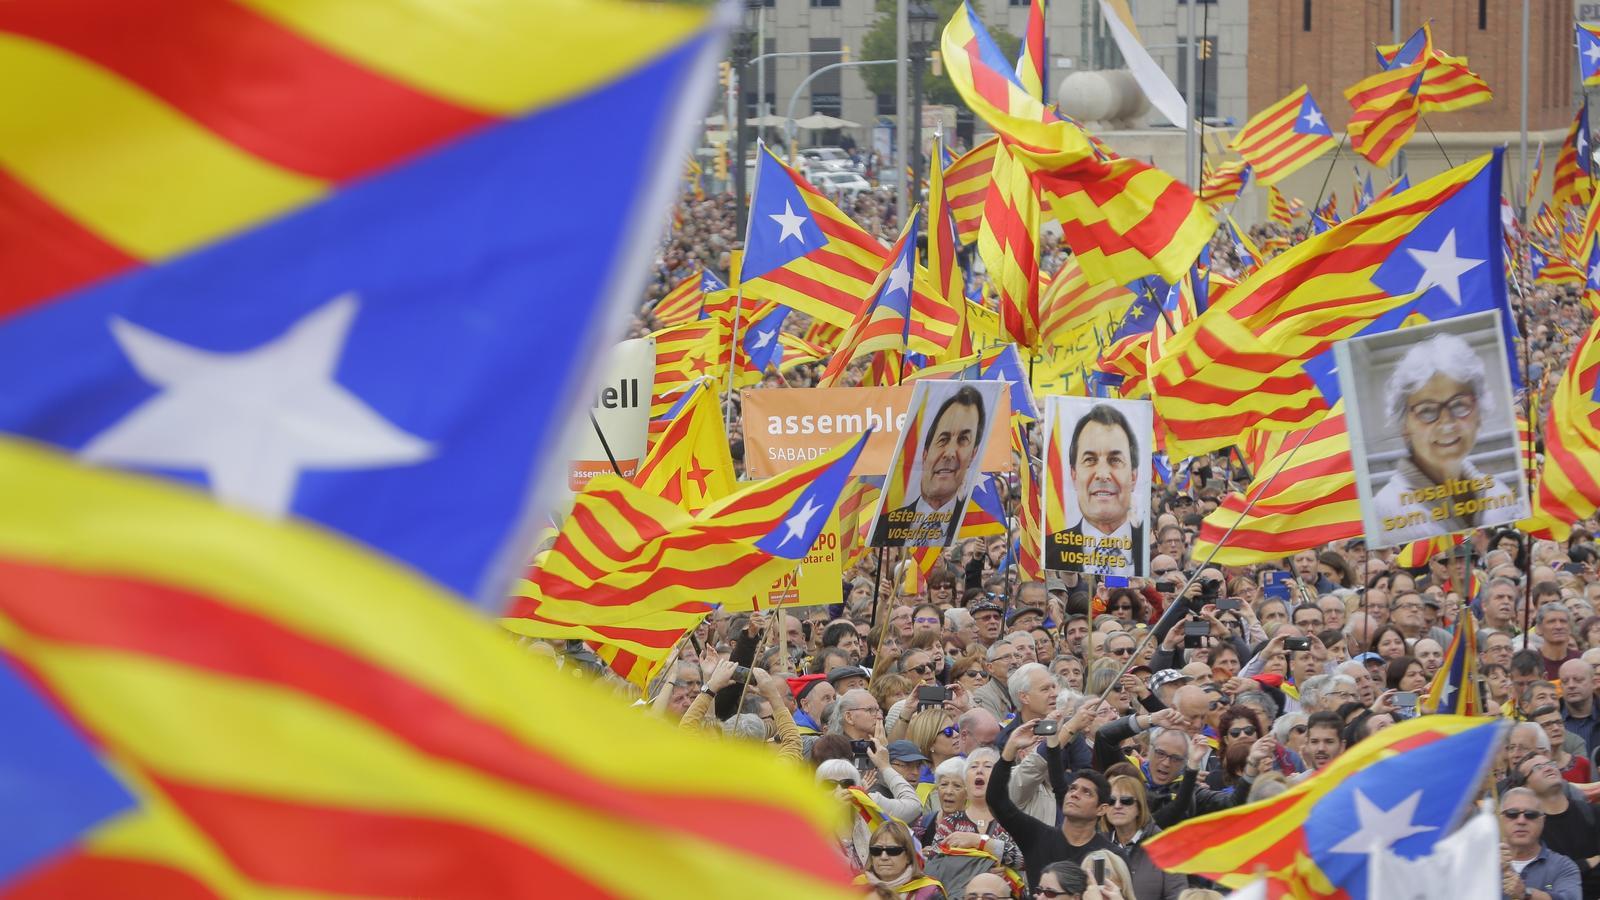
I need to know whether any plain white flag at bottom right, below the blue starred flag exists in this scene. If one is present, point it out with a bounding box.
[1366,800,1501,900]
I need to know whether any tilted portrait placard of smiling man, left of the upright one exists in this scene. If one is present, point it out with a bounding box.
[870,381,1010,546]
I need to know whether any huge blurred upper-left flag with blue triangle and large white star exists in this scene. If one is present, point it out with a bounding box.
[0,0,717,604]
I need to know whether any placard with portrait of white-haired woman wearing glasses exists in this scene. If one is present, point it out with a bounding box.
[1334,312,1530,548]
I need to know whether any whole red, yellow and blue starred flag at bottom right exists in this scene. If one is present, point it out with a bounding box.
[1146,716,1506,900]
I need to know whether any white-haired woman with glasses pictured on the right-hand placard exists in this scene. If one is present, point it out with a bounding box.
[1373,333,1528,544]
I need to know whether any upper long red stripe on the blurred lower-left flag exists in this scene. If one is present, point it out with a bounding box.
[0,560,851,874]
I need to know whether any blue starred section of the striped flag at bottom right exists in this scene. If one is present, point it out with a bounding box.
[1304,722,1502,900]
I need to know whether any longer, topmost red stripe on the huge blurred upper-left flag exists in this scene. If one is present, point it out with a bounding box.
[0,0,493,181]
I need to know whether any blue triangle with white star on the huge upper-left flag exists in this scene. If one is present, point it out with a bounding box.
[0,21,715,609]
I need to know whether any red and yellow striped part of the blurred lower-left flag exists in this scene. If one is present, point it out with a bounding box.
[0,432,843,897]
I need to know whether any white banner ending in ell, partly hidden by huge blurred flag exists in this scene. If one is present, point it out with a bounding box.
[566,338,656,493]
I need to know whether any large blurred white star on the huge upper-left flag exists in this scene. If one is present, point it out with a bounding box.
[82,295,432,517]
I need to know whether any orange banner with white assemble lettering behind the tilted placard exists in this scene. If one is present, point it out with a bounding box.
[741,383,1013,479]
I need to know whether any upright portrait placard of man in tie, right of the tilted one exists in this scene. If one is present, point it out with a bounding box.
[1043,397,1154,577]
